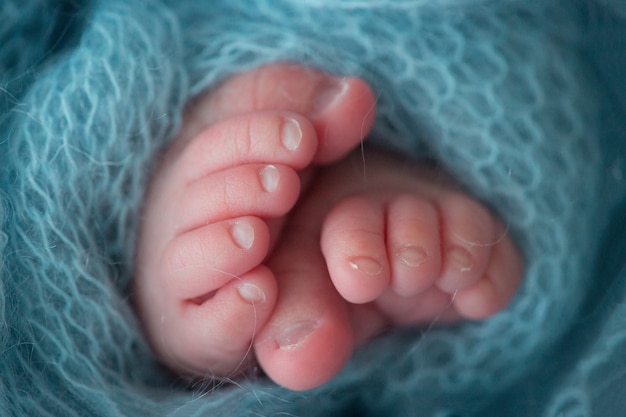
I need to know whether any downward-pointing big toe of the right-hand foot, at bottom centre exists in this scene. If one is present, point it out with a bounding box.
[255,229,354,390]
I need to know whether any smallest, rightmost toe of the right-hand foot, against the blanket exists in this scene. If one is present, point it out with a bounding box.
[454,224,523,319]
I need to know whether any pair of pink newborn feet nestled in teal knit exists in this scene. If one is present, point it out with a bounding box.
[136,64,522,390]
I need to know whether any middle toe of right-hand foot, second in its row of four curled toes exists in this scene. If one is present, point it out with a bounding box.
[386,194,441,297]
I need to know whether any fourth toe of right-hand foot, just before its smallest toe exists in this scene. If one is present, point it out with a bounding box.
[437,192,498,294]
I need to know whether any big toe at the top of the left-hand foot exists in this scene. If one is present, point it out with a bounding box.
[187,63,376,163]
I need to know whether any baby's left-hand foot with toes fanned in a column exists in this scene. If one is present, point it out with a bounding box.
[135,64,374,377]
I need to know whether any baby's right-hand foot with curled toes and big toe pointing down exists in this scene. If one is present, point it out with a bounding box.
[255,148,522,389]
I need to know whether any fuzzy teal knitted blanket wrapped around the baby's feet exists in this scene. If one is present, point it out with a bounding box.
[0,0,626,417]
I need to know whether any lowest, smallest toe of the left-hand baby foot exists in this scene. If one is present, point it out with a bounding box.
[159,266,277,378]
